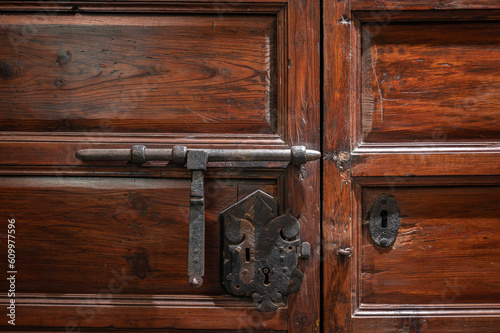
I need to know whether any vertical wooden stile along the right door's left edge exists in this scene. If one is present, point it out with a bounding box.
[322,1,358,332]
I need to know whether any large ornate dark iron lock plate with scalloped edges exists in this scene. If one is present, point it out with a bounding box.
[220,191,311,312]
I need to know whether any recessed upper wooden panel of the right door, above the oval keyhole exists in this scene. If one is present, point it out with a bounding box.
[362,22,500,142]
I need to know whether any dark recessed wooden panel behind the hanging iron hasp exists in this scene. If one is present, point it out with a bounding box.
[0,177,276,295]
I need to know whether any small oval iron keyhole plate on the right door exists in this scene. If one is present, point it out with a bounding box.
[369,193,399,247]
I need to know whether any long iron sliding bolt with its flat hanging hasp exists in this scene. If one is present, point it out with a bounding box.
[75,145,321,287]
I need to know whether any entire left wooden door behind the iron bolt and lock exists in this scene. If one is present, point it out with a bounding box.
[0,0,320,332]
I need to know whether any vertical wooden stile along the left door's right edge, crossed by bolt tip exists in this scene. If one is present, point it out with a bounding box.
[282,0,321,333]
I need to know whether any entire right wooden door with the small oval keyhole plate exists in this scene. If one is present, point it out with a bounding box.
[323,0,500,332]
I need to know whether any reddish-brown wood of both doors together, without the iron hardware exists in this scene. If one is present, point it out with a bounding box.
[0,0,500,333]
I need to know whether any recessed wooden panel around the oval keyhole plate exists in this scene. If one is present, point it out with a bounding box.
[360,186,500,308]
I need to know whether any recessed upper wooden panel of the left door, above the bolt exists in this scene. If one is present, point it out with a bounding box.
[0,14,278,134]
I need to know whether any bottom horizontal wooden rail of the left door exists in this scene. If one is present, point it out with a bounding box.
[6,295,288,332]
